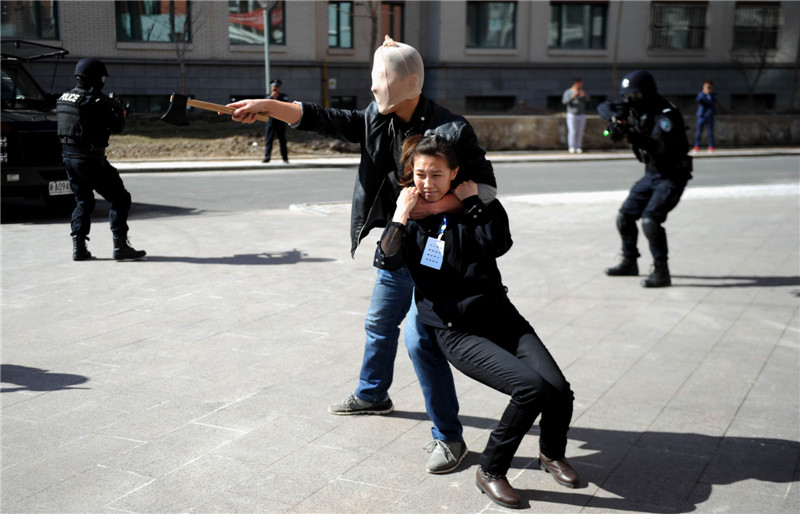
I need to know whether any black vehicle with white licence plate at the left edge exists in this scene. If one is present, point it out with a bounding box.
[0,40,74,207]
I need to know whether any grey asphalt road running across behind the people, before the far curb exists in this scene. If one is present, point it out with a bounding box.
[2,155,800,223]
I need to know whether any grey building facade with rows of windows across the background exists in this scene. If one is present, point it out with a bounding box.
[6,0,800,114]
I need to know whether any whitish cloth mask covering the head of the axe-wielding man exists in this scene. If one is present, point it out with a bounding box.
[372,36,425,114]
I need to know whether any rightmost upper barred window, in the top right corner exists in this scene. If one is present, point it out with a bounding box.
[733,2,781,50]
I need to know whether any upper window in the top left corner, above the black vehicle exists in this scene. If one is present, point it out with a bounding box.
[0,0,60,39]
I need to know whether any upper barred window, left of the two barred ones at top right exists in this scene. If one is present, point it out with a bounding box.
[648,2,708,50]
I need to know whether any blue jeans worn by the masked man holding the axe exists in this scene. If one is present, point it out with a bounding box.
[356,266,462,441]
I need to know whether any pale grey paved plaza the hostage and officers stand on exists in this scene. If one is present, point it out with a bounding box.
[0,167,800,513]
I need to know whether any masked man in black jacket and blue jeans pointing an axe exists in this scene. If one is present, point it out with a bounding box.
[229,36,496,473]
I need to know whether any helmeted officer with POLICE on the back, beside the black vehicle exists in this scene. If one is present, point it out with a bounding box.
[56,58,146,261]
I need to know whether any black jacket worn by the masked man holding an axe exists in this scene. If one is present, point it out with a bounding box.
[296,96,497,254]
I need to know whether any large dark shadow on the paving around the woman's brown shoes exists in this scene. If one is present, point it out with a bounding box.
[390,411,800,512]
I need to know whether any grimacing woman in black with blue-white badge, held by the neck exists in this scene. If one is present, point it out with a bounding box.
[375,135,578,508]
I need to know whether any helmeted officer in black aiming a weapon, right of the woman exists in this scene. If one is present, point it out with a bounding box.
[597,70,692,287]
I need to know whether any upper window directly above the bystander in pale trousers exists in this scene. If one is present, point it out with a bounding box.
[549,2,608,49]
